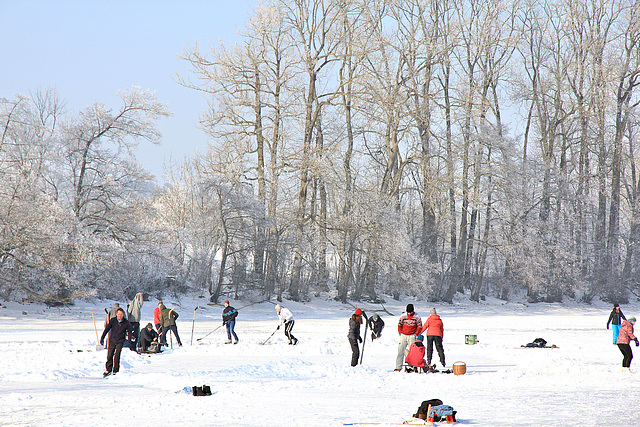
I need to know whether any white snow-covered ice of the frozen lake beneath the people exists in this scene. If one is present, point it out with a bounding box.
[0,299,640,426]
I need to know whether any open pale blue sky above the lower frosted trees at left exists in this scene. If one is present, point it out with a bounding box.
[0,0,257,184]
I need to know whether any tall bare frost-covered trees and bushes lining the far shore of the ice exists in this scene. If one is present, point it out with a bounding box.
[0,0,640,308]
